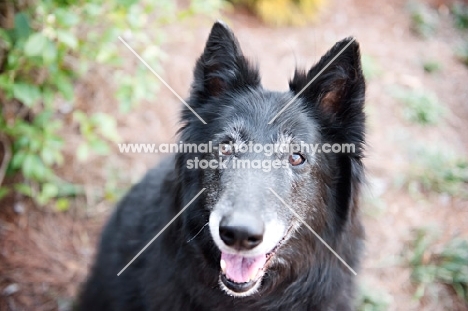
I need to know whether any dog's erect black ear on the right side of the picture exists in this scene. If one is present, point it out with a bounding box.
[289,38,365,130]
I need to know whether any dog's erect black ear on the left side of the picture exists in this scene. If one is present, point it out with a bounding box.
[192,21,260,98]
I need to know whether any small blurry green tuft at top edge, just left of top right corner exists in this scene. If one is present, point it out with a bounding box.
[407,1,438,38]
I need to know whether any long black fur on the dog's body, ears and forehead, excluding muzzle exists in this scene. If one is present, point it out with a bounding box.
[76,22,365,311]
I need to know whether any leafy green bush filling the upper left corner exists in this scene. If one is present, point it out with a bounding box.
[0,0,220,210]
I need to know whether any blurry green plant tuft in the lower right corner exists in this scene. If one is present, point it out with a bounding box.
[407,229,468,302]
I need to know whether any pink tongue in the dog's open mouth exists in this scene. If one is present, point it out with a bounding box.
[221,253,266,283]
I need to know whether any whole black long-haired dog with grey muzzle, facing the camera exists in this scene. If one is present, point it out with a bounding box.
[77,22,365,311]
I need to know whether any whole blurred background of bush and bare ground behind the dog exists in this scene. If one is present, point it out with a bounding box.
[0,0,468,311]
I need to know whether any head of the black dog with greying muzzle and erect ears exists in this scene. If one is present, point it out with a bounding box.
[181,22,365,297]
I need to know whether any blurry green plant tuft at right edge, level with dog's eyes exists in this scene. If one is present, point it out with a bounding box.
[407,146,468,198]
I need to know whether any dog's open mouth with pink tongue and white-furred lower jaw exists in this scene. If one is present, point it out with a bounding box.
[219,230,289,296]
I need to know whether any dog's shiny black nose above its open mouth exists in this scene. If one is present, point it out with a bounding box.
[219,214,264,250]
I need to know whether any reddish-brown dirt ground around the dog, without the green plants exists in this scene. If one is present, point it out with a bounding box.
[0,0,468,311]
